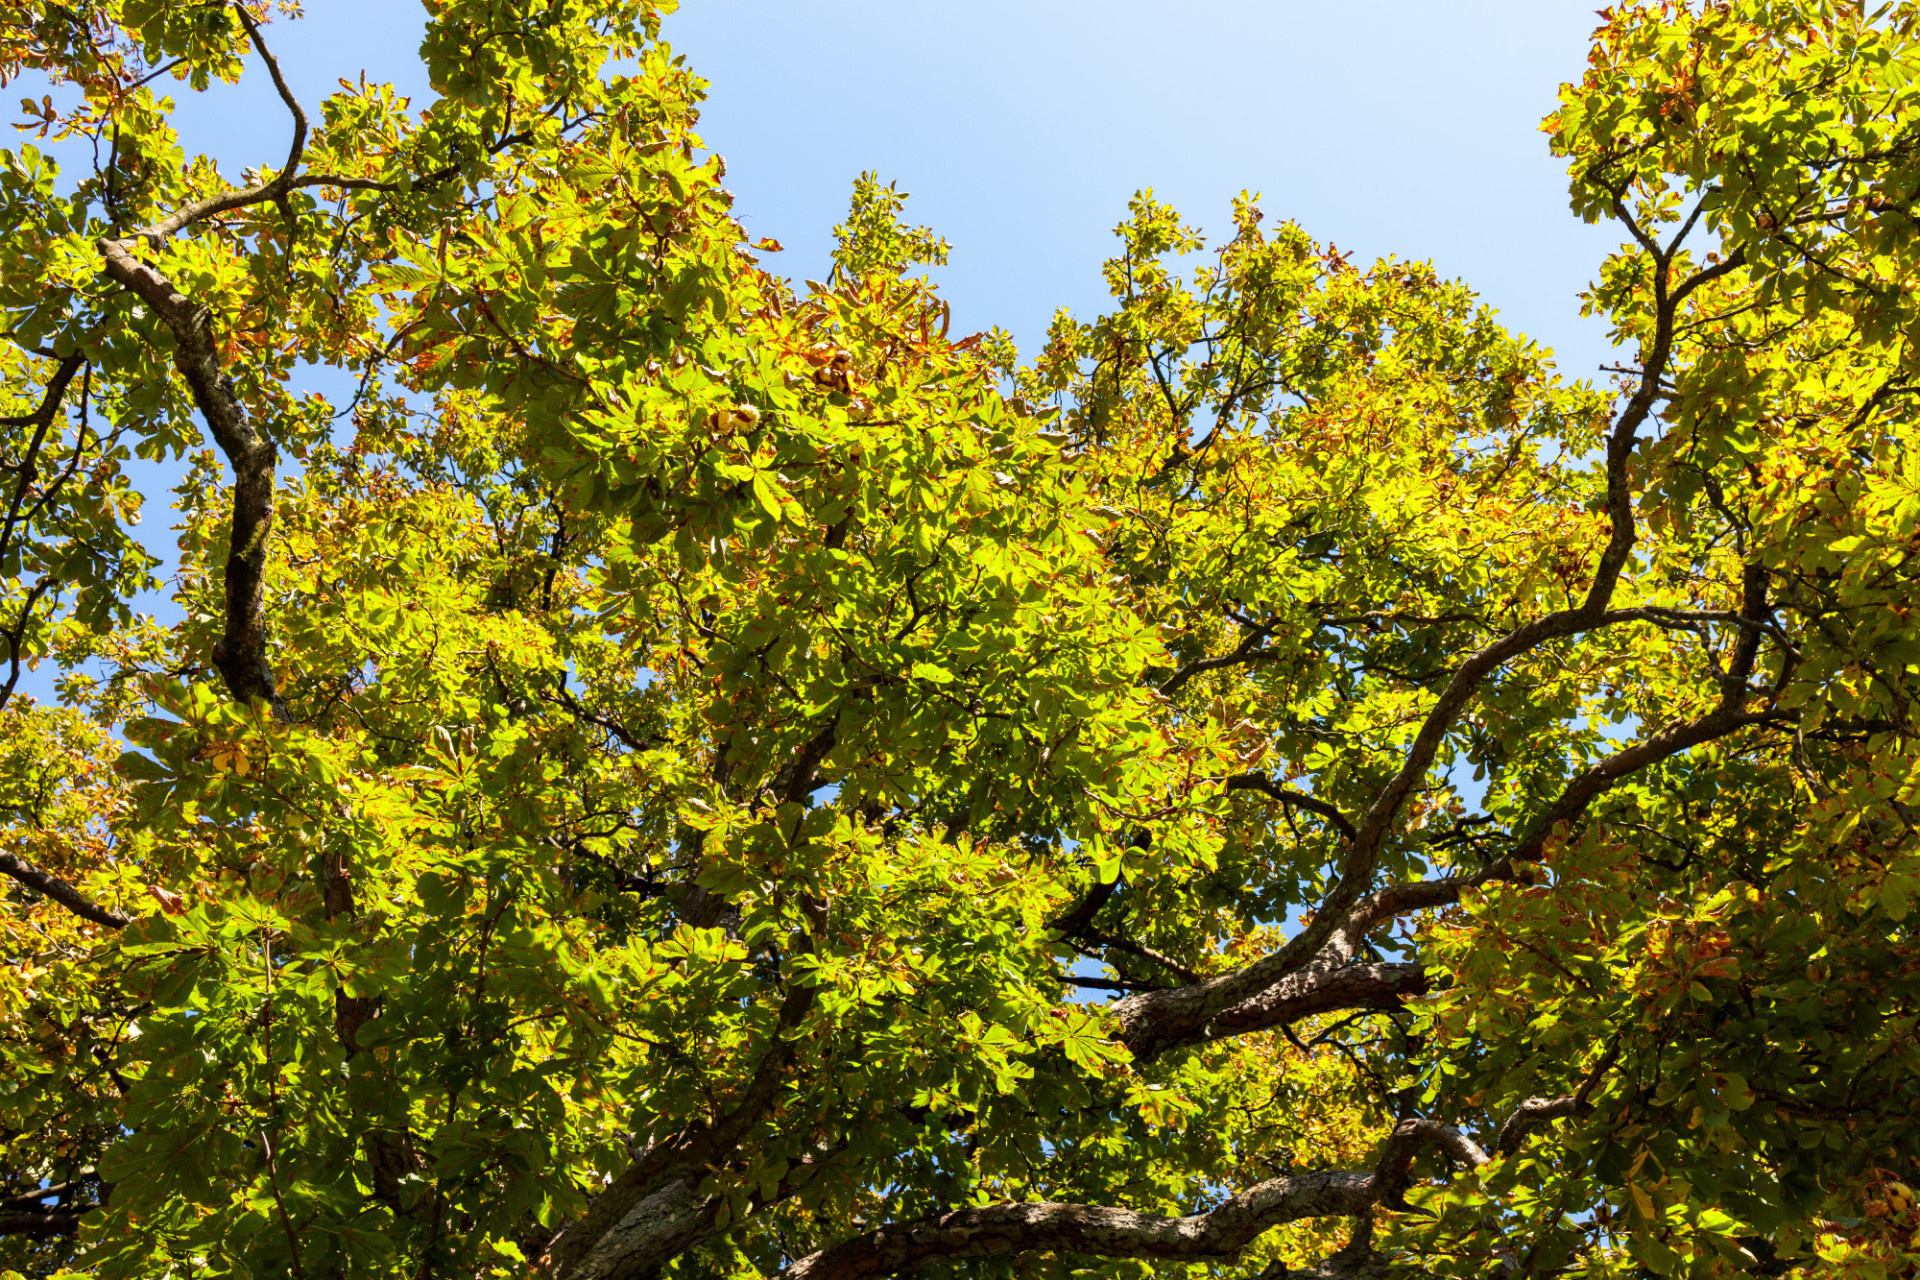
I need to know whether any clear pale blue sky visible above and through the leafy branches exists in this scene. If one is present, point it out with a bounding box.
[18,0,1615,697]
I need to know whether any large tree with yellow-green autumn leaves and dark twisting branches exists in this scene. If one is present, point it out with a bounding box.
[0,0,1920,1280]
